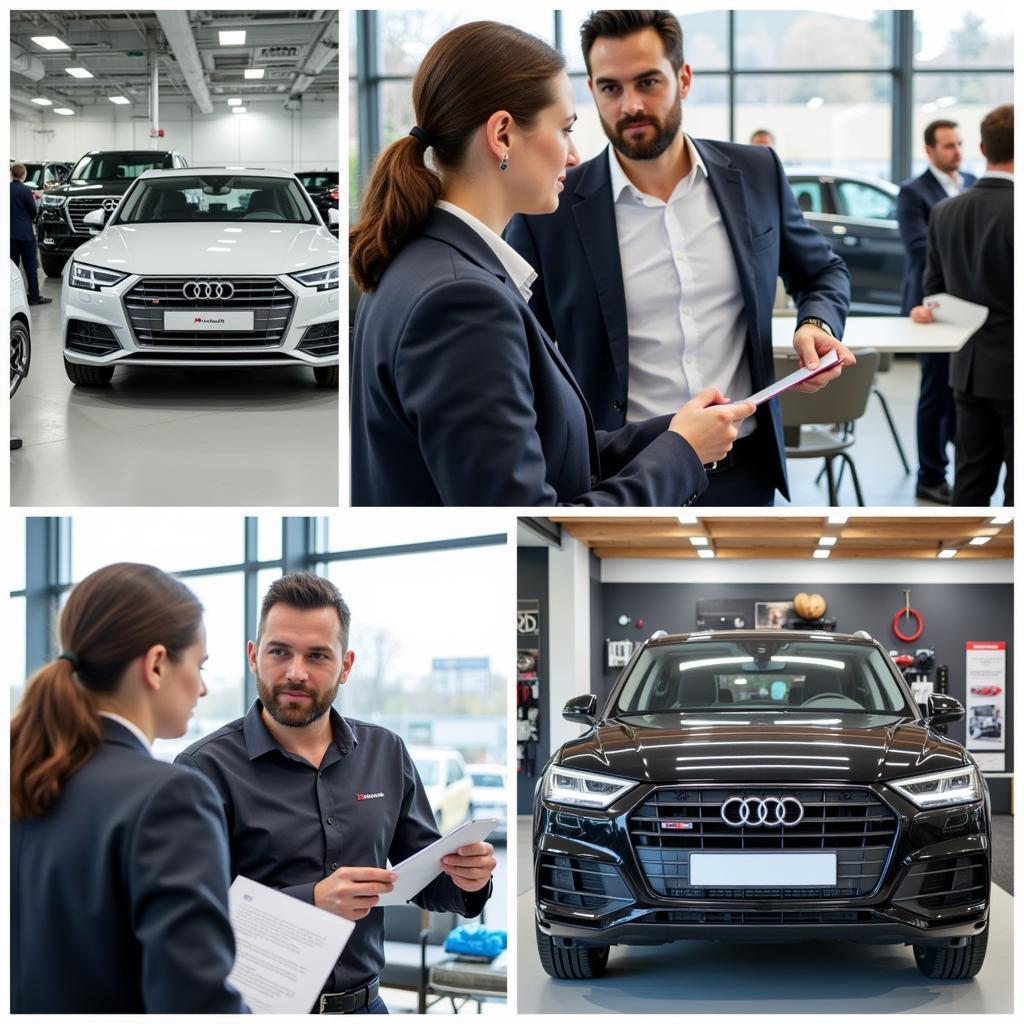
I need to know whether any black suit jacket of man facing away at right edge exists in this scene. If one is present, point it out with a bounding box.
[925,178,1014,398]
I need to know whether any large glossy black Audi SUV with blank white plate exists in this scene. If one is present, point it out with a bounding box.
[534,631,991,978]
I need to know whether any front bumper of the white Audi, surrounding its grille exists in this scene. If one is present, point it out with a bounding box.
[60,272,340,367]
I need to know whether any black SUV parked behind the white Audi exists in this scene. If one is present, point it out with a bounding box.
[36,150,188,278]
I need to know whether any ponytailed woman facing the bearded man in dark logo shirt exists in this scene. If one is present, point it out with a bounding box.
[10,563,247,1014]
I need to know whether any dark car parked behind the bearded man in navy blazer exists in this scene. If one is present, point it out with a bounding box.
[785,167,905,315]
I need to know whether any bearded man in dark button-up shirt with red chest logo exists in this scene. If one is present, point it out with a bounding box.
[177,572,496,1013]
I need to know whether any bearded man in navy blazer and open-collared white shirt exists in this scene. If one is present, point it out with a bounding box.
[507,10,854,505]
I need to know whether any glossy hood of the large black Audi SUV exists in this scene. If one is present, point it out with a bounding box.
[555,711,969,784]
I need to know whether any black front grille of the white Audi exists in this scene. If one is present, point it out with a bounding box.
[124,276,295,350]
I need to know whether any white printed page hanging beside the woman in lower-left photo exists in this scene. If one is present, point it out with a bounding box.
[227,874,355,1014]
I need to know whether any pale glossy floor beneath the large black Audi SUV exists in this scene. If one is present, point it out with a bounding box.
[517,815,1014,1014]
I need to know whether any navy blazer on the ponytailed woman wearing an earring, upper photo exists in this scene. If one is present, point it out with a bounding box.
[351,209,708,506]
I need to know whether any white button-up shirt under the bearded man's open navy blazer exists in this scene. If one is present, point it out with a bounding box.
[608,134,755,436]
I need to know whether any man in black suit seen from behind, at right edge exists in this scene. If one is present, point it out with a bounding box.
[911,103,1014,506]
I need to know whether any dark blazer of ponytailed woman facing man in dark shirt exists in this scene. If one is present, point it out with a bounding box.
[10,719,246,1014]
